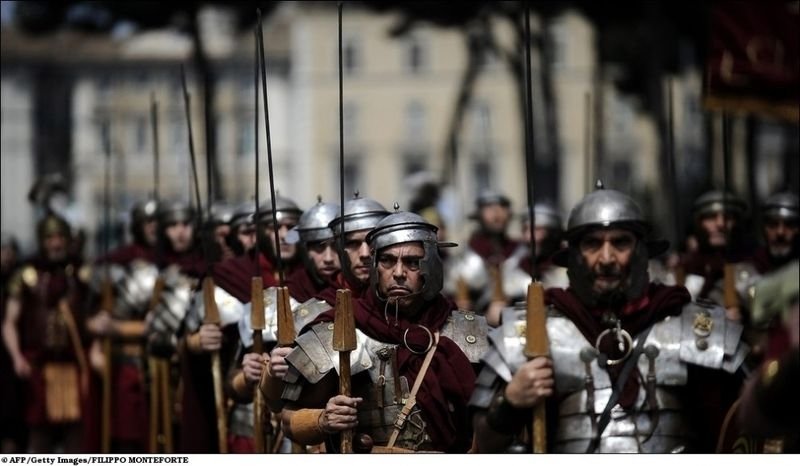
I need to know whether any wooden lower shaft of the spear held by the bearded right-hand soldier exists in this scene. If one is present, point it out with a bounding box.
[525,282,548,453]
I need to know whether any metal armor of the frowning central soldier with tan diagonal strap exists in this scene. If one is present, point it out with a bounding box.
[283,311,489,450]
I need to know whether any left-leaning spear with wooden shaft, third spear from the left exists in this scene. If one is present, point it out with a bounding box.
[181,66,228,453]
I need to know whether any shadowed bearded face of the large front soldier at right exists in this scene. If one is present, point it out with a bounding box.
[579,228,636,295]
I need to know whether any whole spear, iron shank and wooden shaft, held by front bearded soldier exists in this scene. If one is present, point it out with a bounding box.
[523,1,548,453]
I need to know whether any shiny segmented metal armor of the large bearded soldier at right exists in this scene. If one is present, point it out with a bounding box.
[470,303,749,453]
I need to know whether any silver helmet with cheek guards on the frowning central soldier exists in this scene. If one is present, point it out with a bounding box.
[366,212,444,301]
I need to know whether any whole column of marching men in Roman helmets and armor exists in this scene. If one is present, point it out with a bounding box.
[0,184,799,453]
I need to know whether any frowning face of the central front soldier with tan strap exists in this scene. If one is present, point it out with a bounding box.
[376,242,425,309]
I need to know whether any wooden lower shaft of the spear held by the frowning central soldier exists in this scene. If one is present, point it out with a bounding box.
[333,290,356,453]
